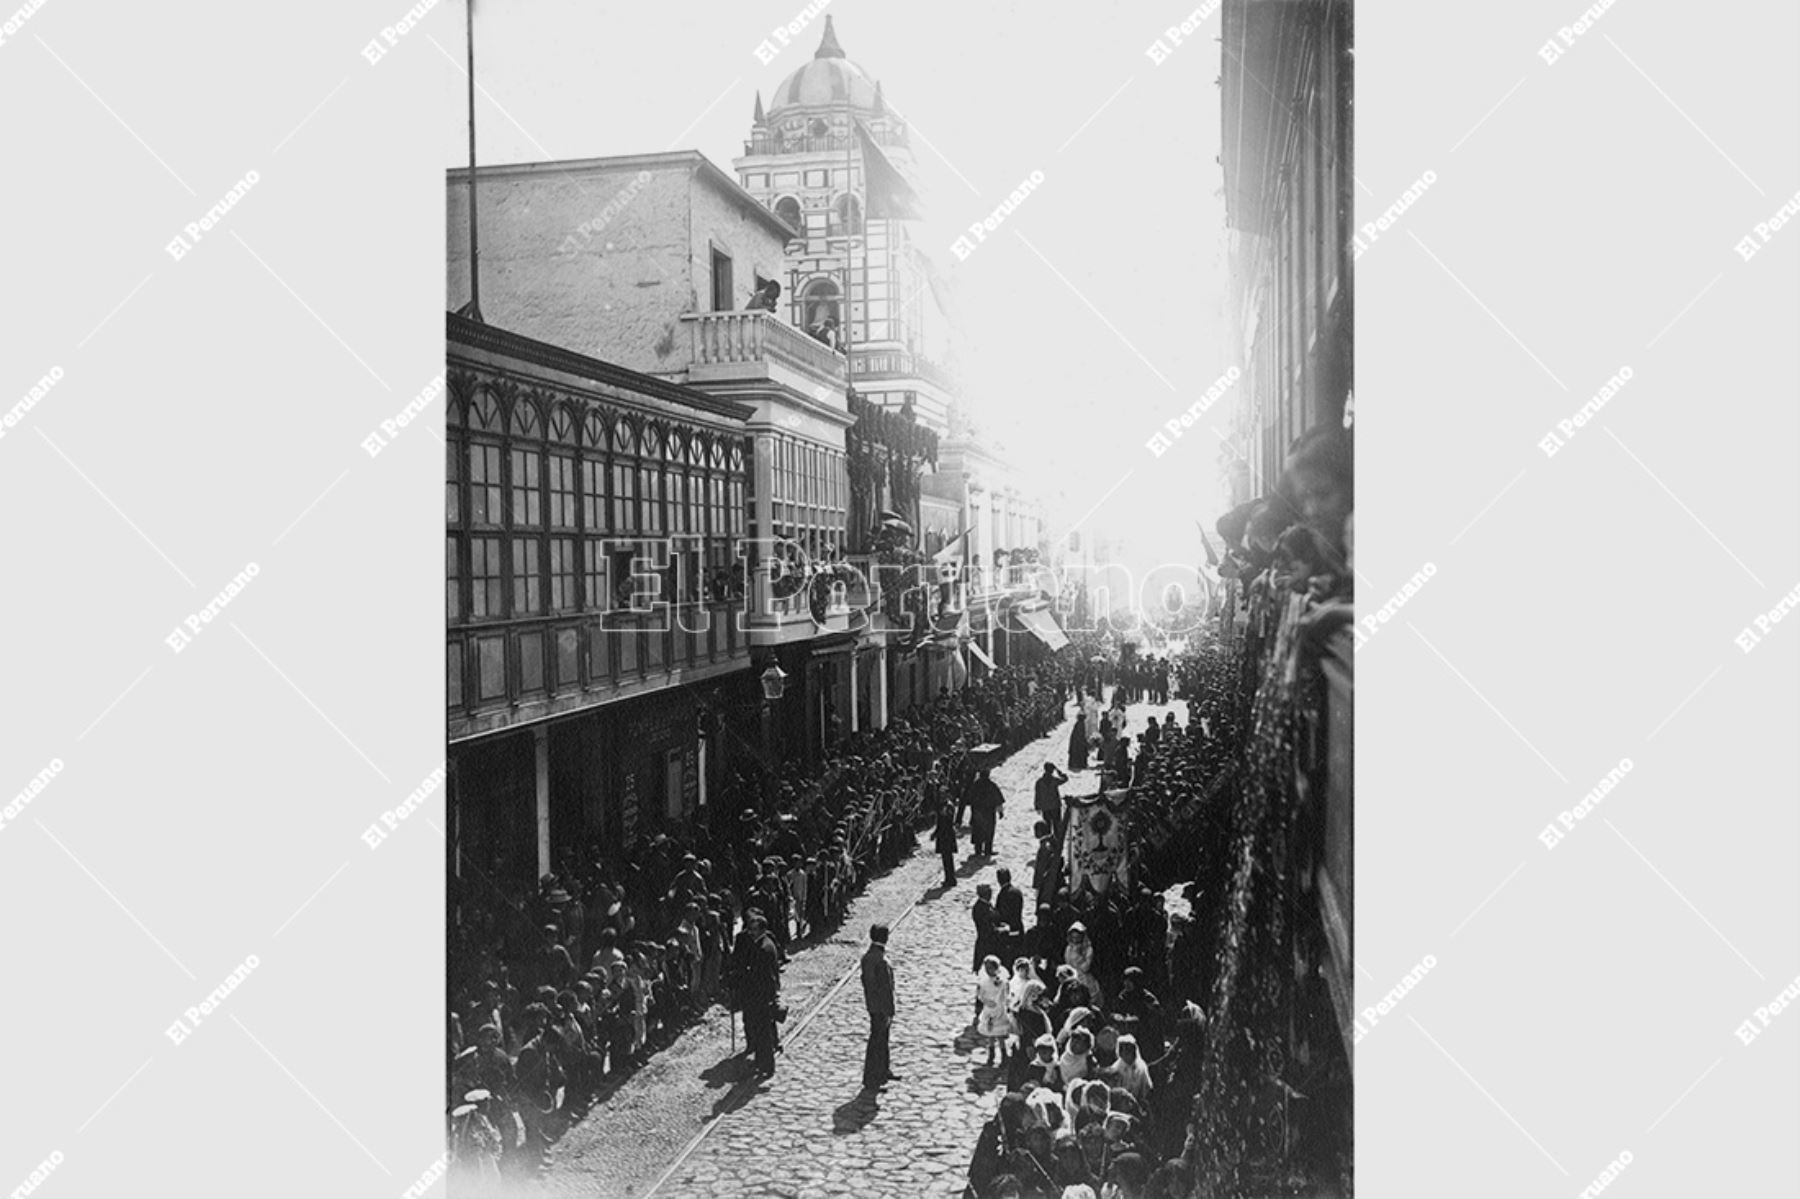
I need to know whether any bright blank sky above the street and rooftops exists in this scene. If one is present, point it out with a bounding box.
[442,0,1237,571]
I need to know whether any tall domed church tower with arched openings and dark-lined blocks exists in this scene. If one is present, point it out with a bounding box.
[733,16,954,434]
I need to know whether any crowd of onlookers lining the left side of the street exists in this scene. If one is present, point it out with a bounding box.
[448,654,1075,1176]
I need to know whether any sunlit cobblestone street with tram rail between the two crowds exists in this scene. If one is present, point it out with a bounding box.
[545,691,1184,1199]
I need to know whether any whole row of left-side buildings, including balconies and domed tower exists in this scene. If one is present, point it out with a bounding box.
[446,30,1065,888]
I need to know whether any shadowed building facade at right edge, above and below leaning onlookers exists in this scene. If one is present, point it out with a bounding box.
[1220,0,1355,1053]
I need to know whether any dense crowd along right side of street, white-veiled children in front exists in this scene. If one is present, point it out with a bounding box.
[965,637,1348,1199]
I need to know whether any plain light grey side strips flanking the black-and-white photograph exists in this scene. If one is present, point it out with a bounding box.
[0,0,1800,1197]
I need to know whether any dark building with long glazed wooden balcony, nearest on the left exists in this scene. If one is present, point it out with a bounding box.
[445,315,754,888]
